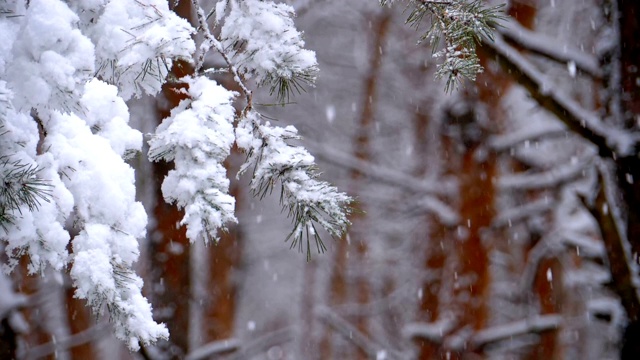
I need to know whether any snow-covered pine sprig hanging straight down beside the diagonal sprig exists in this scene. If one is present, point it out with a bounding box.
[149,77,236,242]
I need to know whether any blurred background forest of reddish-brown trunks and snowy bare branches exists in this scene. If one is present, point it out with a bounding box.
[0,0,640,360]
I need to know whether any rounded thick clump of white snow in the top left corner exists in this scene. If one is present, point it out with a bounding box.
[3,0,94,111]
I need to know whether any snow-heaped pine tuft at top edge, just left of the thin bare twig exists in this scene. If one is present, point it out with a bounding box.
[70,0,195,100]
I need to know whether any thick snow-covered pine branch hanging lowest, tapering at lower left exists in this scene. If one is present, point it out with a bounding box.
[44,109,168,350]
